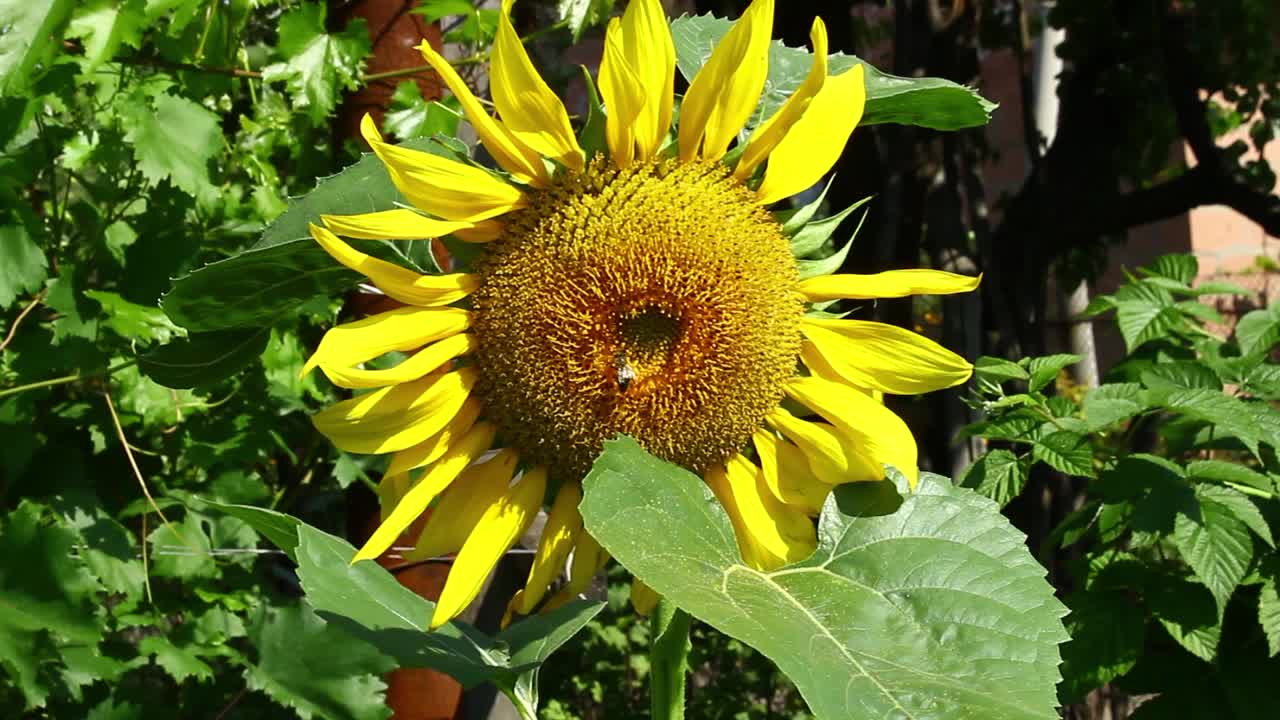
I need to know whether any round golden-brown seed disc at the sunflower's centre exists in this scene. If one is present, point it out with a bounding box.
[472,160,803,477]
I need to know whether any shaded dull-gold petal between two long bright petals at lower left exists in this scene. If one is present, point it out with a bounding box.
[404,448,518,560]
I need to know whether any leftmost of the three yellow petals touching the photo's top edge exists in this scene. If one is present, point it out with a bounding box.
[489,0,582,170]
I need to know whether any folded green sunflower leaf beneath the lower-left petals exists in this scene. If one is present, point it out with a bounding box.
[296,523,603,689]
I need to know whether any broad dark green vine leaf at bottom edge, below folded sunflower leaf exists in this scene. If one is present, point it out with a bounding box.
[247,603,396,720]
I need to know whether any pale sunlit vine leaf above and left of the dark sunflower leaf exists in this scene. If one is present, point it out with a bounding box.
[120,94,223,196]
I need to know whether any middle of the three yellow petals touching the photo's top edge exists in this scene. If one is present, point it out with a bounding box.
[614,0,676,160]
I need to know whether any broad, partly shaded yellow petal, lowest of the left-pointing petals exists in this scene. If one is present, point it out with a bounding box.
[311,368,477,455]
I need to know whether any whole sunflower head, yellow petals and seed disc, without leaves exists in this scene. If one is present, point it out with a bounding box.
[305,0,978,628]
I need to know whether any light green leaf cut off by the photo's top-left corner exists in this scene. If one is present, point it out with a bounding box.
[0,0,76,95]
